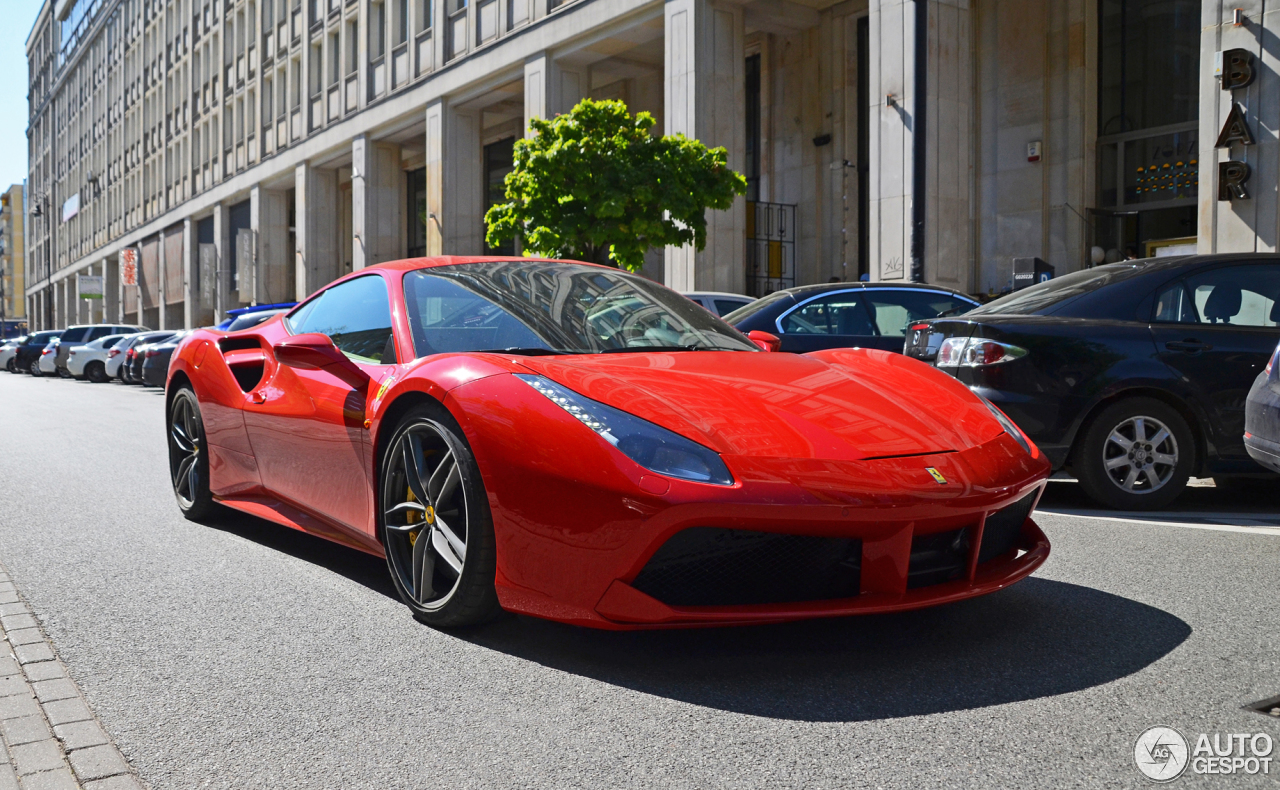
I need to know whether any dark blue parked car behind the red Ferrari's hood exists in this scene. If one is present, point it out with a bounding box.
[724,283,978,353]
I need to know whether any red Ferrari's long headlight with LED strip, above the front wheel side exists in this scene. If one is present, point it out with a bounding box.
[516,374,733,485]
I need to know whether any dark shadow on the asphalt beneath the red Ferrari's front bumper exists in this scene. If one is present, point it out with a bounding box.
[458,579,1192,722]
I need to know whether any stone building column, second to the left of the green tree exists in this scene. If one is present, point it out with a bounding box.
[351,134,406,271]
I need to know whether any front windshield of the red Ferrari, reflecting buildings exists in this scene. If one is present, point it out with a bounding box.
[404,260,758,356]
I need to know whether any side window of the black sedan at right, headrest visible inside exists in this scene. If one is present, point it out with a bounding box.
[1156,264,1280,328]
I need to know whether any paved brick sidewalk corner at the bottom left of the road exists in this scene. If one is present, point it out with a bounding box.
[0,565,143,790]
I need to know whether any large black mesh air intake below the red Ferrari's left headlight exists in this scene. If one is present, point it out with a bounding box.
[631,526,863,606]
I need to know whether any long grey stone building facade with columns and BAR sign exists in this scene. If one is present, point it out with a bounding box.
[15,0,1280,328]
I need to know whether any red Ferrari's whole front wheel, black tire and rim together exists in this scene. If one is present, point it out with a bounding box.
[379,406,500,627]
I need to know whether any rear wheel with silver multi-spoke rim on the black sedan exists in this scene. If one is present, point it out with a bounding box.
[1074,397,1196,510]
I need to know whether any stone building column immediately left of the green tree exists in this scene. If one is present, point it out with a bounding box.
[426,99,484,255]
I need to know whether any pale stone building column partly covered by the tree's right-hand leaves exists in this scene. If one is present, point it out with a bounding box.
[664,0,746,293]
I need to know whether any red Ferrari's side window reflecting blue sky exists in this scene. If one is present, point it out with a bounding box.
[289,274,396,365]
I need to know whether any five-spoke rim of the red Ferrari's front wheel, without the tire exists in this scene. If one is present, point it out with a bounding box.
[383,423,470,609]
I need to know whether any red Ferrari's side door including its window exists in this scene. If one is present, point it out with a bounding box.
[244,274,396,534]
